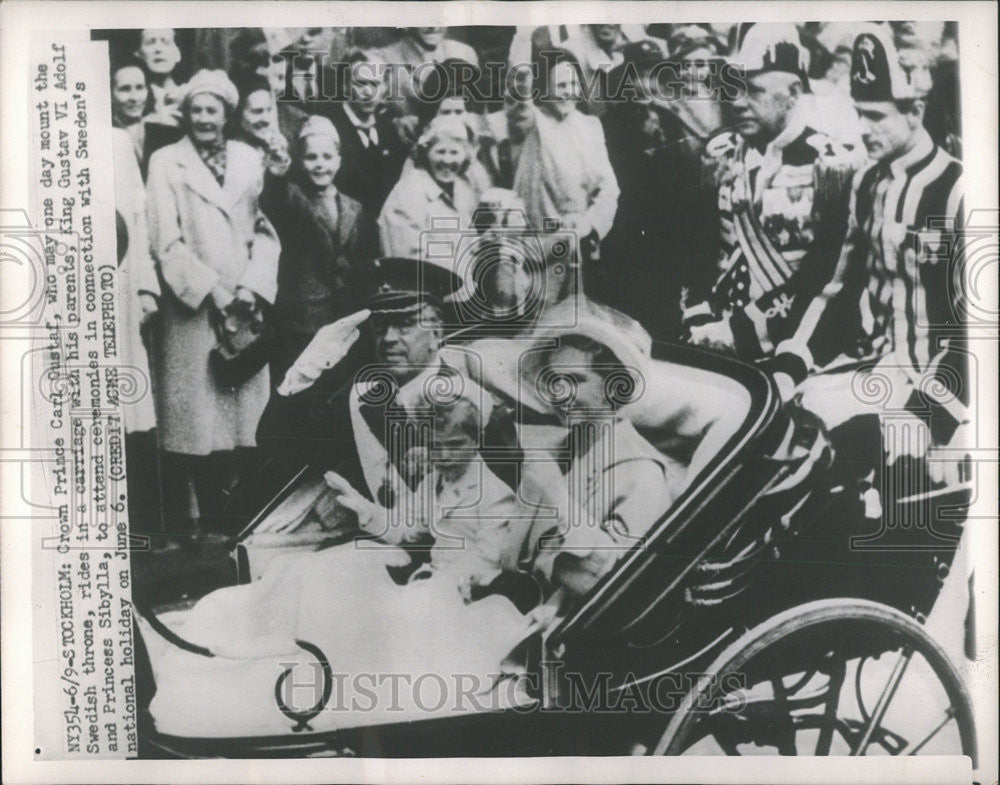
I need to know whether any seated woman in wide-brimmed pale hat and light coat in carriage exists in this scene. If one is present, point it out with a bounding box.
[521,309,684,606]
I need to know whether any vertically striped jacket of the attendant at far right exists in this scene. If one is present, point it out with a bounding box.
[772,131,968,439]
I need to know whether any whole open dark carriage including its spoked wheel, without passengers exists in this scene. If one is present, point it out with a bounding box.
[129,346,976,759]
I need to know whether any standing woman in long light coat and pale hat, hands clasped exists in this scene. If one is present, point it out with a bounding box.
[148,70,279,540]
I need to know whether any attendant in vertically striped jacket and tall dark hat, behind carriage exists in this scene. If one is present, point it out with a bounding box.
[773,26,968,483]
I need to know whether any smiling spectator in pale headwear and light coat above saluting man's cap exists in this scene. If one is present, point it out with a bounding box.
[378,117,479,260]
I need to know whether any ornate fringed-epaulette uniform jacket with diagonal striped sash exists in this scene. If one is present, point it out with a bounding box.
[684,124,861,360]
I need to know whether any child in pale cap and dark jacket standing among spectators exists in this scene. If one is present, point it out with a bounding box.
[260,115,378,383]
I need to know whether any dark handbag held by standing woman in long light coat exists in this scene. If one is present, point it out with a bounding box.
[209,295,275,389]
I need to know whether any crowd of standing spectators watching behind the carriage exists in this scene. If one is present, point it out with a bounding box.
[94,22,961,547]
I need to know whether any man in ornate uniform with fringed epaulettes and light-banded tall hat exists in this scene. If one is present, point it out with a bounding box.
[682,24,859,360]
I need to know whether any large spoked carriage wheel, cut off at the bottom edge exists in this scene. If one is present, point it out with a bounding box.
[653,599,976,766]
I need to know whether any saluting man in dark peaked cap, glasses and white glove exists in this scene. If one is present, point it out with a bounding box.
[257,258,516,507]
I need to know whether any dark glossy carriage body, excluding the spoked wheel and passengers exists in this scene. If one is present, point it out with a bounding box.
[133,345,967,757]
